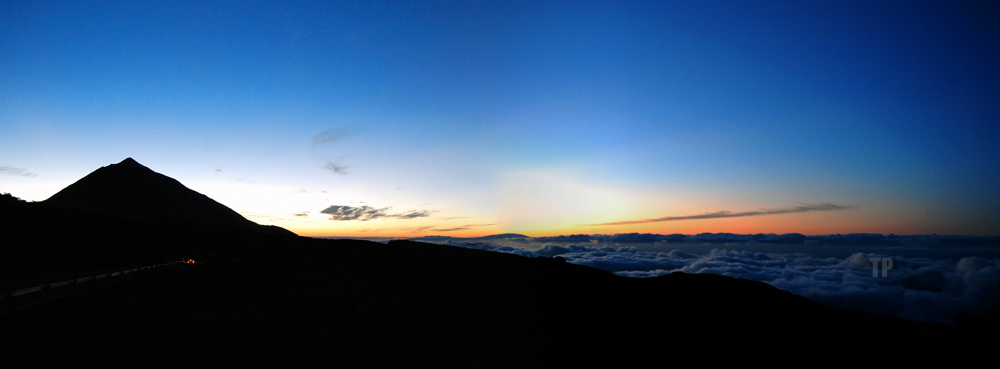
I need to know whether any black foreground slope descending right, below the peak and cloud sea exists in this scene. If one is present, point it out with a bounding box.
[0,233,975,367]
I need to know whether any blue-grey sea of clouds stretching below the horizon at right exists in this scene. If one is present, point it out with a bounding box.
[408,234,1000,323]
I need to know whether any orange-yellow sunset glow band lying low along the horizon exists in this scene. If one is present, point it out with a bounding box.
[287,197,952,238]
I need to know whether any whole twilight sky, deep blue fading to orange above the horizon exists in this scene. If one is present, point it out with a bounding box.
[0,0,1000,237]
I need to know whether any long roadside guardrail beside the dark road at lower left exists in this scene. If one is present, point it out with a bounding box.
[0,260,194,314]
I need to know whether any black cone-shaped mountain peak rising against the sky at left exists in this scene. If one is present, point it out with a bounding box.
[42,158,257,226]
